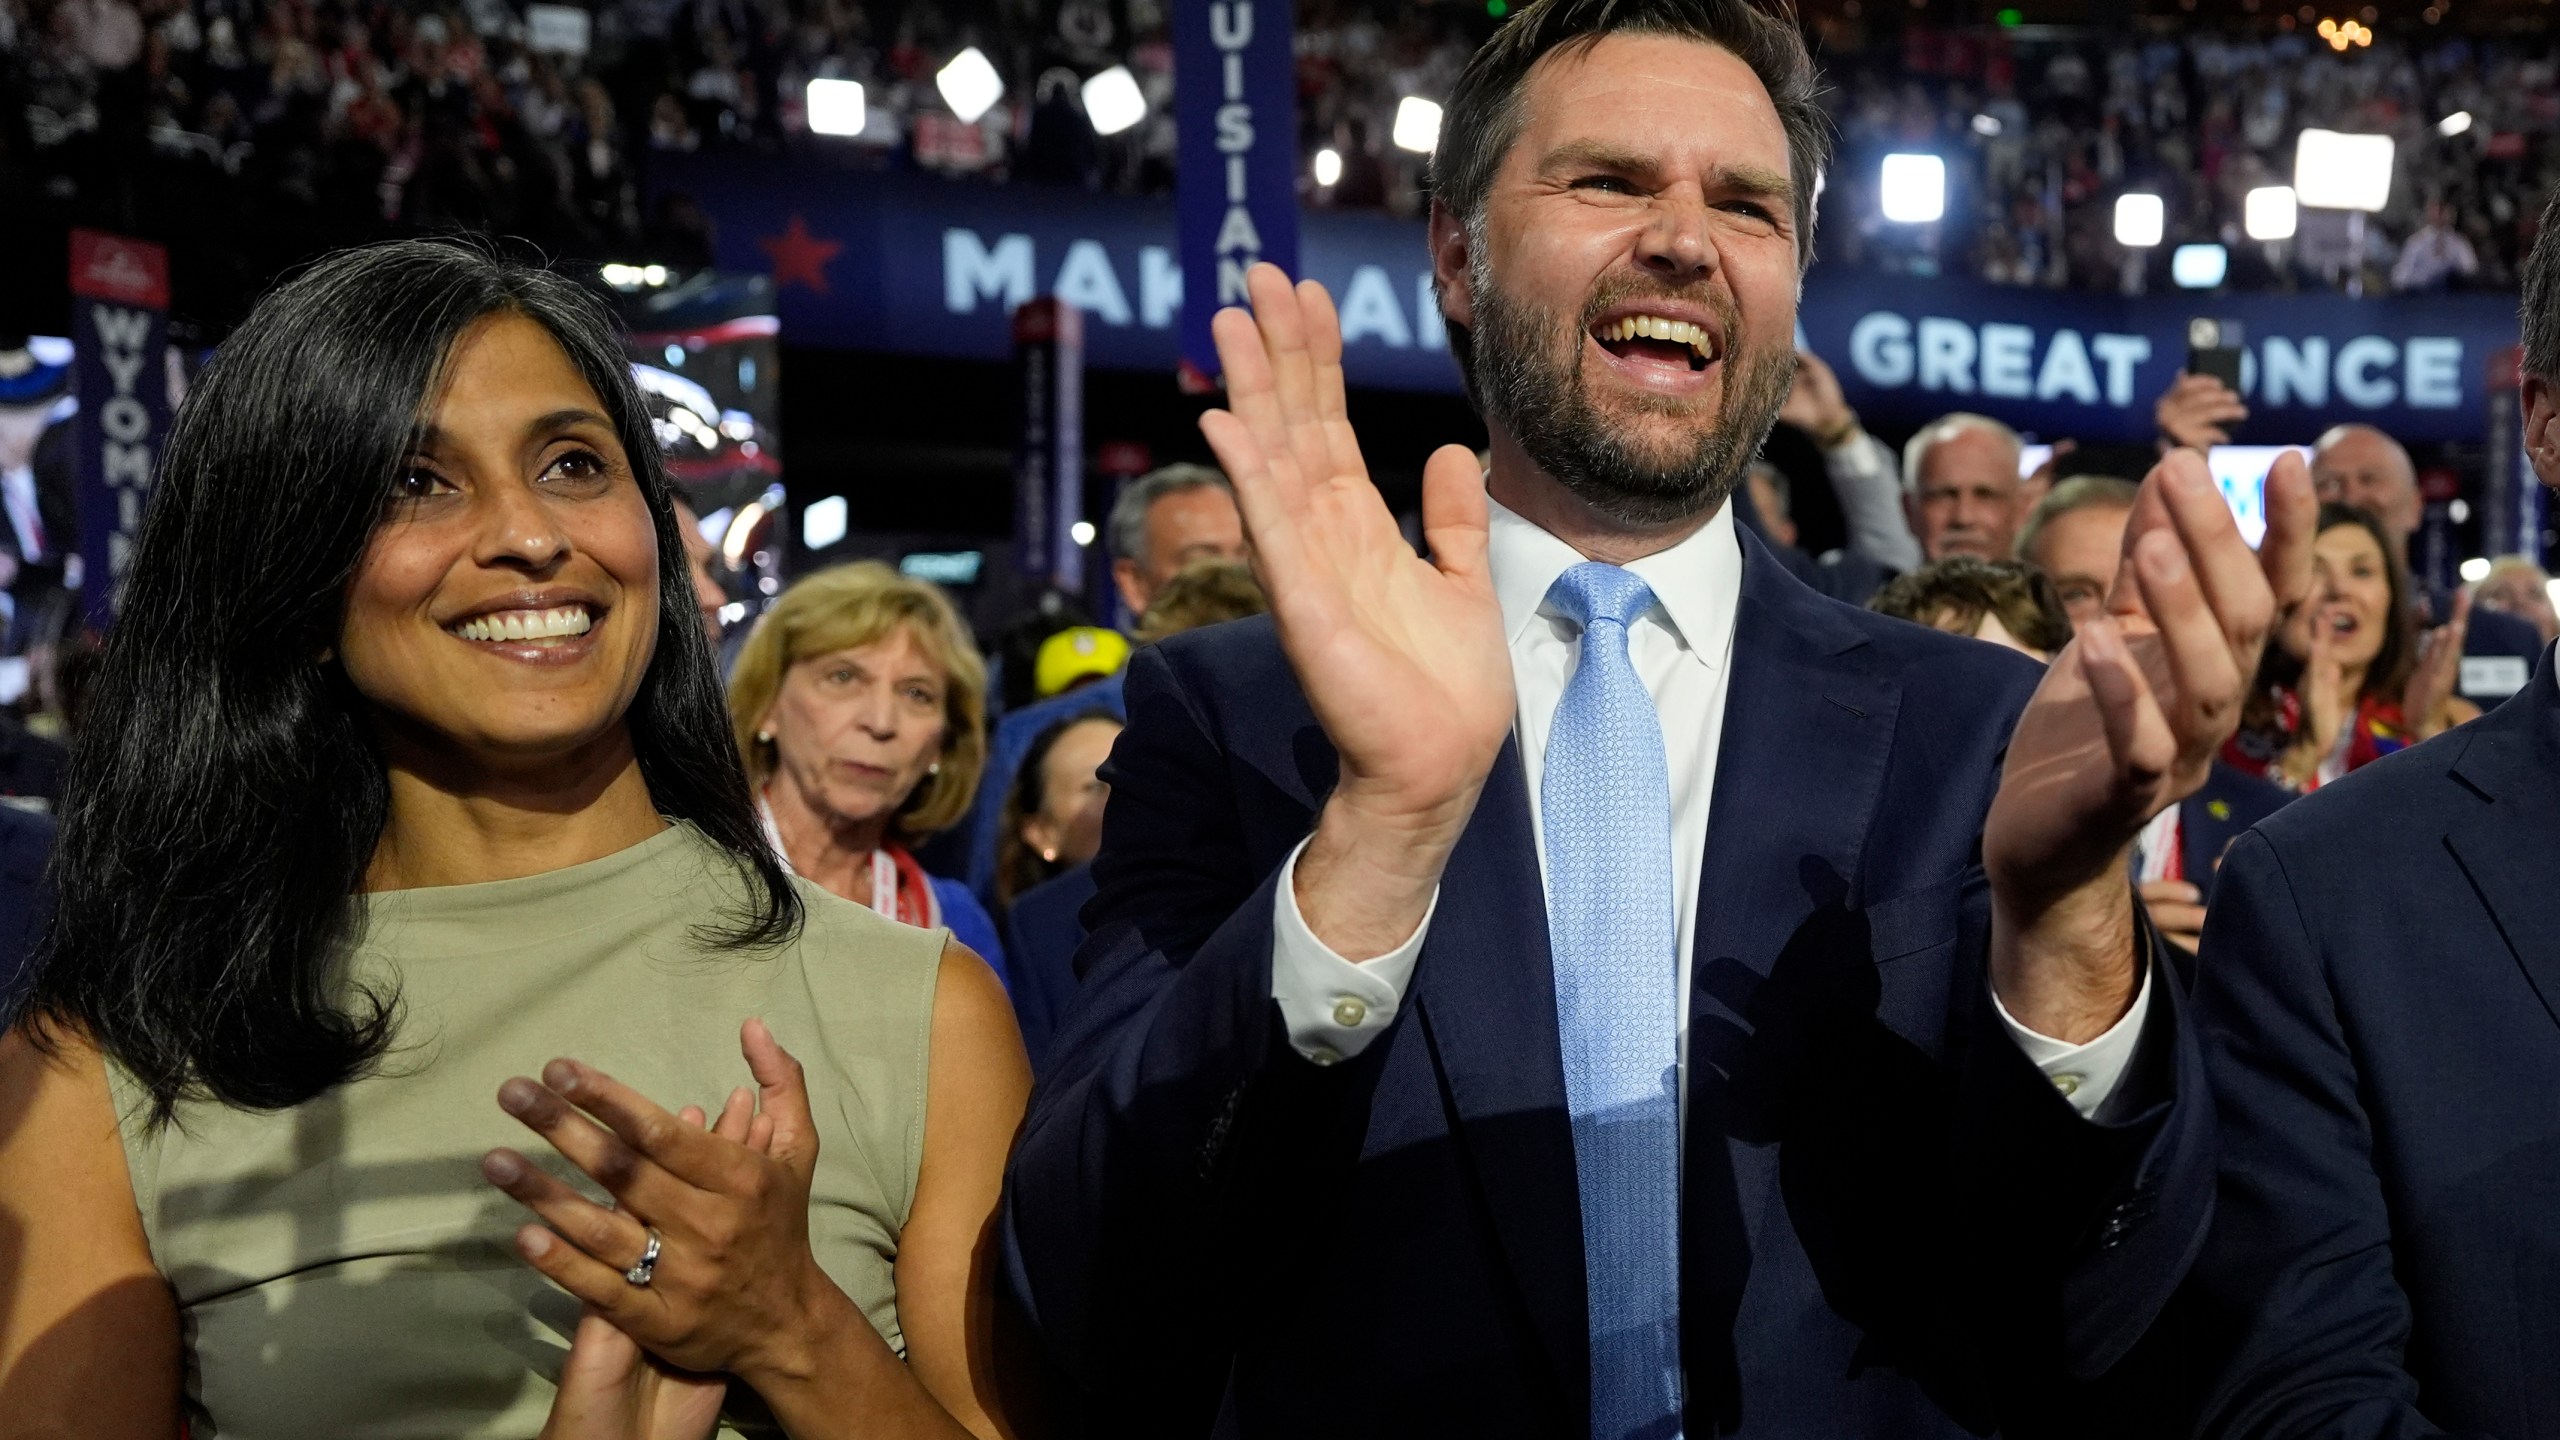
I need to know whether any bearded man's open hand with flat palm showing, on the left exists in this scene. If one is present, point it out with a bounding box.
[1201,264,1513,958]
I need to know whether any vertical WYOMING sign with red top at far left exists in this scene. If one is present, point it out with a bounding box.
[72,231,169,630]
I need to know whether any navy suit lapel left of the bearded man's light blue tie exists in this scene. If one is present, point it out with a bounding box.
[1413,740,1590,1414]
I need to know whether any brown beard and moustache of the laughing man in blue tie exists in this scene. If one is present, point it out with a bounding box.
[1472,264,1795,528]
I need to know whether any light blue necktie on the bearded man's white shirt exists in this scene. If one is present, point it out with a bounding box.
[1539,564,1682,1440]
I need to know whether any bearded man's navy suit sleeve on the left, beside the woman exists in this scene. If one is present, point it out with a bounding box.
[1004,648,1388,1430]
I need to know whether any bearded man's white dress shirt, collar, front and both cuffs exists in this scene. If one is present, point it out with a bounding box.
[1272,502,2150,1115]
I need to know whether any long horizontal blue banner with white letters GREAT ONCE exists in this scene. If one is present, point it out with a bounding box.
[655,156,2516,443]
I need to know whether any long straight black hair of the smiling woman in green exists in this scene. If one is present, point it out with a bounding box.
[26,241,801,1120]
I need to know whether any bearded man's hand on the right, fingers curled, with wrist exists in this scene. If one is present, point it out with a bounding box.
[1981,448,2317,1043]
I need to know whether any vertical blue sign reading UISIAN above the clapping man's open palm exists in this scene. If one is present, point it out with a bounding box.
[1172,0,1298,377]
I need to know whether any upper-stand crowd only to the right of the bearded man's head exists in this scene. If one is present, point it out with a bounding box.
[1825,26,2560,292]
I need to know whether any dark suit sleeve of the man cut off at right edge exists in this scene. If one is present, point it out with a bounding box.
[2189,833,2442,1440]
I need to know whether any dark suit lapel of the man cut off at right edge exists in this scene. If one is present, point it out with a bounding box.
[2445,674,2560,1022]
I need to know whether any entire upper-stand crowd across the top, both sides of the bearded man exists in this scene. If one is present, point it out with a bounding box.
[0,0,2560,292]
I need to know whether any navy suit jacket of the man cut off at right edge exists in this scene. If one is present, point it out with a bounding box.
[2181,659,2560,1440]
